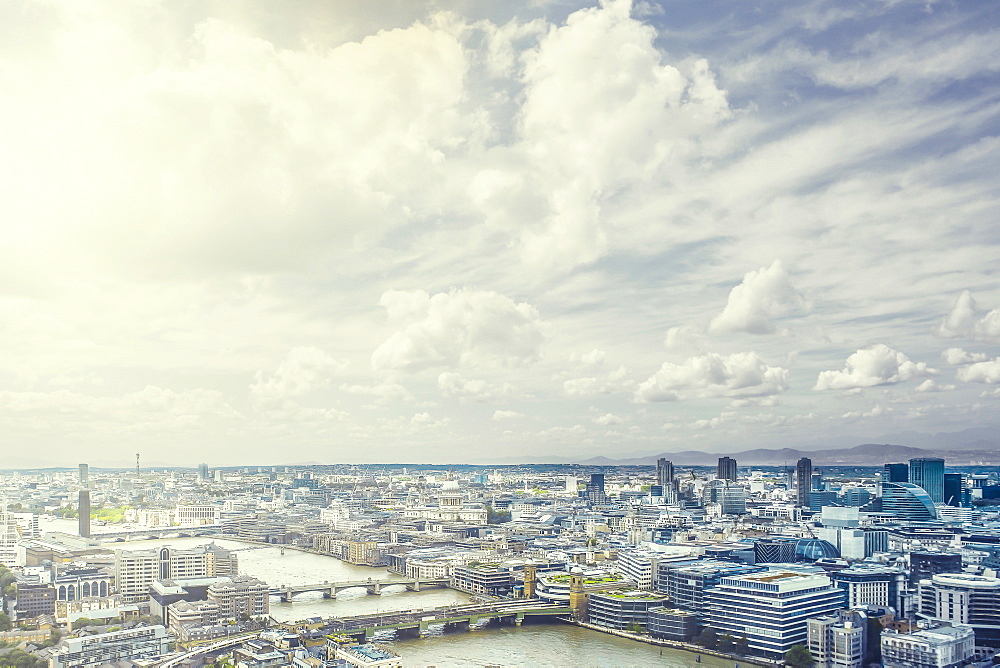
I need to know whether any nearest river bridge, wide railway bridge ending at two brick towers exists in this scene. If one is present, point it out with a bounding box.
[325,599,572,642]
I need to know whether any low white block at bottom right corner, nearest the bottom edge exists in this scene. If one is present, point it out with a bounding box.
[880,624,976,668]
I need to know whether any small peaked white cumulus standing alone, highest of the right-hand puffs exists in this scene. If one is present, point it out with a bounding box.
[709,260,806,334]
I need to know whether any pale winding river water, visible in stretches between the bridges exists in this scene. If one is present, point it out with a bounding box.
[42,520,748,668]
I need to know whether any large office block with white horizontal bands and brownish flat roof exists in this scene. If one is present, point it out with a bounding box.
[705,570,846,660]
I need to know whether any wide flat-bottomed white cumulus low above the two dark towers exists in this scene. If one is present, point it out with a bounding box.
[635,352,788,402]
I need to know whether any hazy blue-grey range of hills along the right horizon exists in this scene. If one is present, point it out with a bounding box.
[578,443,1000,466]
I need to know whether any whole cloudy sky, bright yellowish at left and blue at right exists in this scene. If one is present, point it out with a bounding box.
[0,0,1000,467]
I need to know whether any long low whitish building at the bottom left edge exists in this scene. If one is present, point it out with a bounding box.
[49,625,170,668]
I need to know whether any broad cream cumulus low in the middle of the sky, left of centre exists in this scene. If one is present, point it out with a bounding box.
[372,288,545,373]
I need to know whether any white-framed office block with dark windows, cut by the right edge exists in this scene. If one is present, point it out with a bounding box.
[917,573,1000,648]
